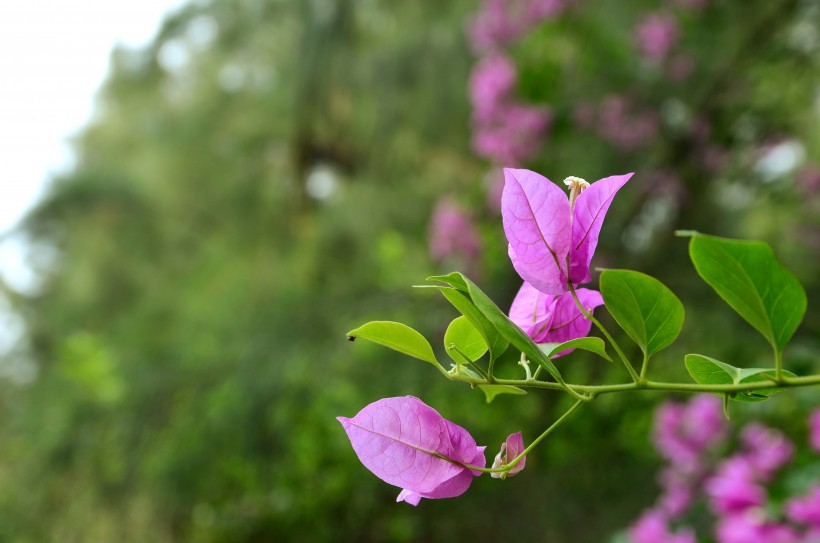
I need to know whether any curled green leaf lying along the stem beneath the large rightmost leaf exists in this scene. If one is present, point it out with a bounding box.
[684,354,795,402]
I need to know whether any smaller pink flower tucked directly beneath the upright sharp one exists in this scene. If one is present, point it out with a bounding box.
[510,283,604,356]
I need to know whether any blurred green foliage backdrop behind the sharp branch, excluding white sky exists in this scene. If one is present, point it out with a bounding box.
[0,0,820,543]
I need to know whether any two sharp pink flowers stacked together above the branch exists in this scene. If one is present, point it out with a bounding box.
[501,168,632,348]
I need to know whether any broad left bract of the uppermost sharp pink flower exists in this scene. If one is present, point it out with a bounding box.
[501,168,572,294]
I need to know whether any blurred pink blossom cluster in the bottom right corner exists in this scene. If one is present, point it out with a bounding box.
[629,395,820,543]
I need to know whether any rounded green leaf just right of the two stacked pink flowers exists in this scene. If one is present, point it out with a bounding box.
[600,270,684,356]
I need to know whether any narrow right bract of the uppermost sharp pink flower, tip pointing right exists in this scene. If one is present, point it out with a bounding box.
[572,173,634,285]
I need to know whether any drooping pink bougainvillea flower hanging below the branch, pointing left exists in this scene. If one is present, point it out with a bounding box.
[337,396,486,505]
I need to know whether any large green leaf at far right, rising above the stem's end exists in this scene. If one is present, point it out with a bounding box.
[689,232,806,352]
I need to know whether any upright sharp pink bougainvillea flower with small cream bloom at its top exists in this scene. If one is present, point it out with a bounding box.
[501,168,633,295]
